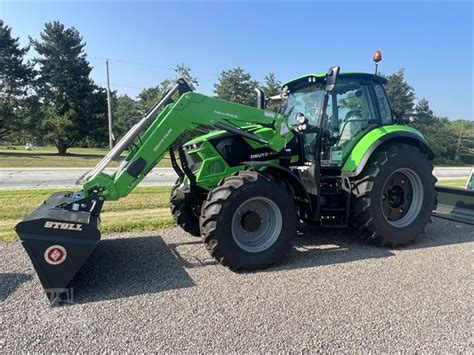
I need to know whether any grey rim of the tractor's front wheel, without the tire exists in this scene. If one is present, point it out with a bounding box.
[232,197,283,253]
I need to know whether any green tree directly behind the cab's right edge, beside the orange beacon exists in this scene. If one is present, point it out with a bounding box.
[385,68,415,121]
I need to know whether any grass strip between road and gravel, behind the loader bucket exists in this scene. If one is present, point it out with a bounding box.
[0,186,174,241]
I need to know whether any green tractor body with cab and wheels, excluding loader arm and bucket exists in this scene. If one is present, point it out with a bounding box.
[171,68,436,269]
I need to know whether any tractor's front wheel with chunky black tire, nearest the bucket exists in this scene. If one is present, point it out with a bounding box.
[200,171,297,270]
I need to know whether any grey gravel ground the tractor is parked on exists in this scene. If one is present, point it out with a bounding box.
[0,220,474,353]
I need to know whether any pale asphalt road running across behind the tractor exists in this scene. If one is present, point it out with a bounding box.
[0,167,471,189]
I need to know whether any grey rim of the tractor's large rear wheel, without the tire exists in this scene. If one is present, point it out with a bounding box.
[381,168,423,228]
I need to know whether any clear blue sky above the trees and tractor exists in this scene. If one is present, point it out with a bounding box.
[0,0,474,120]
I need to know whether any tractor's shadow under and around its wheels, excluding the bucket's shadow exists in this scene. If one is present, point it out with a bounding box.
[160,218,474,274]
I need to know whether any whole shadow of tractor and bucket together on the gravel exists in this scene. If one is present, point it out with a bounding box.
[66,219,474,303]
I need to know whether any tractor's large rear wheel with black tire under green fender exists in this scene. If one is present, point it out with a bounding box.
[351,144,436,246]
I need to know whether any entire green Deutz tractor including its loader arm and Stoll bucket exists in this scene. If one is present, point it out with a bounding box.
[16,67,436,303]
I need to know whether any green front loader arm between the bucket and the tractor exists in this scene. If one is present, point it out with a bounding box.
[83,82,293,200]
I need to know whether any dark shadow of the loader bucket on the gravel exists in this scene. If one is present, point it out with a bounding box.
[70,236,195,303]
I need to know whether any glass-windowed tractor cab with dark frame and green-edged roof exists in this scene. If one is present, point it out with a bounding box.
[282,73,394,167]
